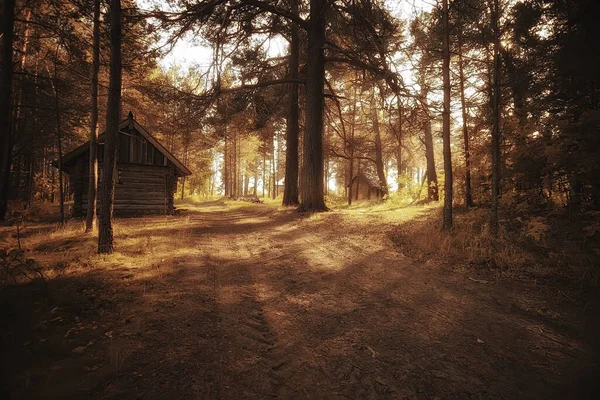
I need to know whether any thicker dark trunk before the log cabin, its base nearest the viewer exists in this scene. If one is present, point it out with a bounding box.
[98,0,121,254]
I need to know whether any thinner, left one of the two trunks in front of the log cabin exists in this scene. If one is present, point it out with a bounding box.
[85,0,100,233]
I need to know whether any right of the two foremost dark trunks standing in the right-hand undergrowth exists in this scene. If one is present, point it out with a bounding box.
[490,0,501,235]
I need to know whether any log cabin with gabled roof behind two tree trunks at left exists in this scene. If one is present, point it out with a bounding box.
[61,112,191,217]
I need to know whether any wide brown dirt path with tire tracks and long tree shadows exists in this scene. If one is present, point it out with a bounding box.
[2,203,594,399]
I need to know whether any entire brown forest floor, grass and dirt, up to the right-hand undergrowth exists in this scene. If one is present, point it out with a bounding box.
[0,201,600,399]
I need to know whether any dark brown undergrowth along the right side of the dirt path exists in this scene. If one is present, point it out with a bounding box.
[392,208,600,287]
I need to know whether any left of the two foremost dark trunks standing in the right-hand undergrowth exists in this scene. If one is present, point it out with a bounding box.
[442,0,452,230]
